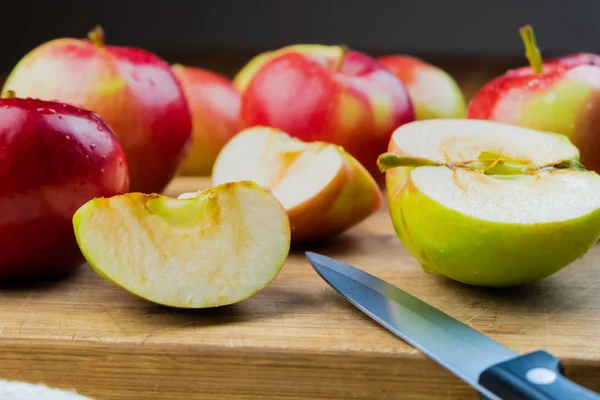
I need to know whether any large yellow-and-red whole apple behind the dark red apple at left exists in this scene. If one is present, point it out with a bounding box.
[4,27,192,193]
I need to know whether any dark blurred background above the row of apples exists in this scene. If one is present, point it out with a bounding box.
[0,0,600,98]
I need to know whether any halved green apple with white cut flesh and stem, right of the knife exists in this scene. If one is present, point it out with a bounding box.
[378,119,600,287]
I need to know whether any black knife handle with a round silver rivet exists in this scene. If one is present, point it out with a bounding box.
[479,351,600,400]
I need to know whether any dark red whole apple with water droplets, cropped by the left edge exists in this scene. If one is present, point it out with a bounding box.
[0,98,129,282]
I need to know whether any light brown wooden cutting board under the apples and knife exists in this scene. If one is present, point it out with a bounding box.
[0,178,600,400]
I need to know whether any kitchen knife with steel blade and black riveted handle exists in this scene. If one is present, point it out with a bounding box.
[306,252,600,400]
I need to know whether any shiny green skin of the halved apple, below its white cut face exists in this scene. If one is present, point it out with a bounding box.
[388,170,600,287]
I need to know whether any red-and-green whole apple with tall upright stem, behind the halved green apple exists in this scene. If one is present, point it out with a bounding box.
[467,25,600,172]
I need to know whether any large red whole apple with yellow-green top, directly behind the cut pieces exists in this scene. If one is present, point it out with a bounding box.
[234,44,415,181]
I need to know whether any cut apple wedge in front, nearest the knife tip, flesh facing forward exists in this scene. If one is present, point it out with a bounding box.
[73,182,290,308]
